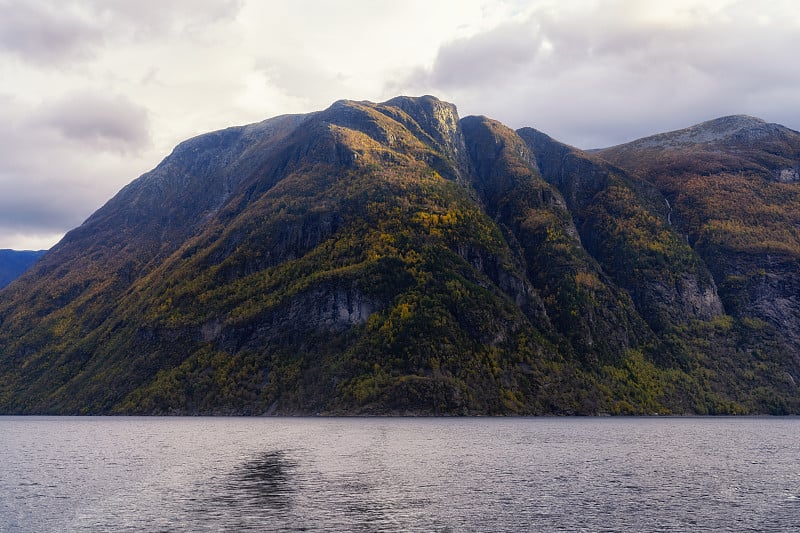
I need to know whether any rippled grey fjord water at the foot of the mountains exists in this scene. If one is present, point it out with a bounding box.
[0,417,800,532]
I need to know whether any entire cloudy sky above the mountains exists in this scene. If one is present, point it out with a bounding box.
[0,0,800,249]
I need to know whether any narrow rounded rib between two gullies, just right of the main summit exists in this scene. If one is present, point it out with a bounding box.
[462,117,652,363]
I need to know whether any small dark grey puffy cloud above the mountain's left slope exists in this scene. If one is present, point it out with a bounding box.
[33,92,150,153]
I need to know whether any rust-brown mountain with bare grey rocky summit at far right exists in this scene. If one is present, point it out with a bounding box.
[598,116,800,366]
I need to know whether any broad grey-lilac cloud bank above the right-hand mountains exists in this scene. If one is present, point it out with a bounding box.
[395,1,800,148]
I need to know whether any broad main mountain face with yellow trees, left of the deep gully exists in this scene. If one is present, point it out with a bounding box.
[0,98,582,413]
